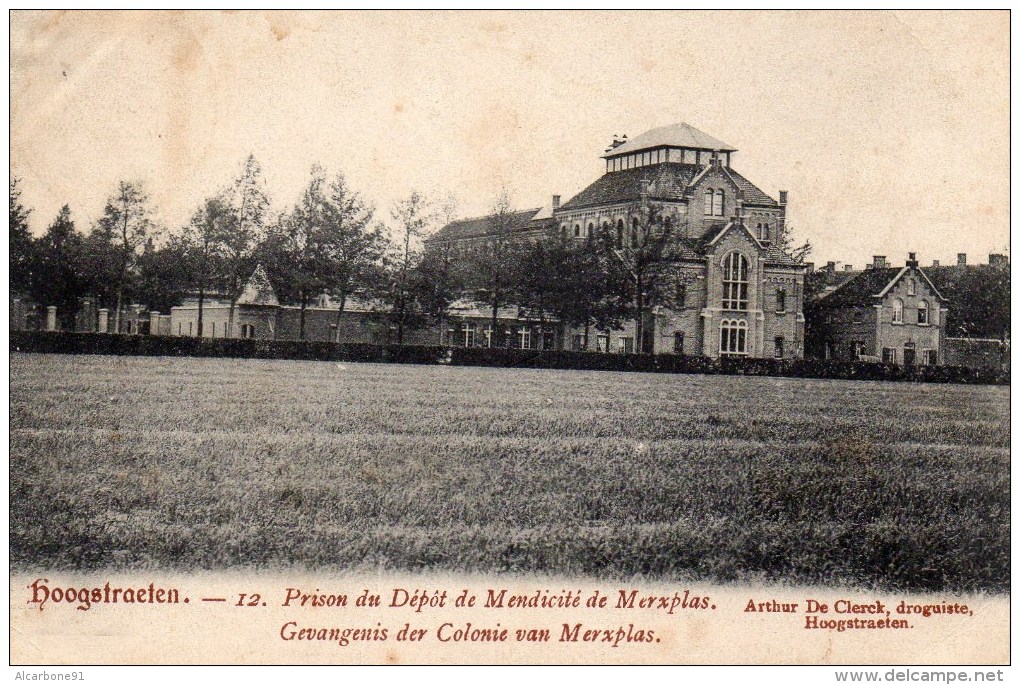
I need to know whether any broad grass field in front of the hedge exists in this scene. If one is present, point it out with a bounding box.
[10,354,1010,592]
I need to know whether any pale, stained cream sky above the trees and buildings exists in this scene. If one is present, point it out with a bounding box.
[10,11,1010,267]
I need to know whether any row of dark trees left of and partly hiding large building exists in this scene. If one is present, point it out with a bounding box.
[10,156,750,347]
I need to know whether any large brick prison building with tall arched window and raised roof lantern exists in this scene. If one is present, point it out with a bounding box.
[430,123,807,359]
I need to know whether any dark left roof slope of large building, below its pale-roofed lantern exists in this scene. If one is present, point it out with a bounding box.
[560,162,702,209]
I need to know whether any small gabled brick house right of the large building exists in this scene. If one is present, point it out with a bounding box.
[808,253,949,366]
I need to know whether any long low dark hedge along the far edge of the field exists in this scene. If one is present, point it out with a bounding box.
[10,330,1010,385]
